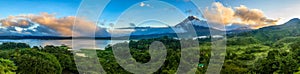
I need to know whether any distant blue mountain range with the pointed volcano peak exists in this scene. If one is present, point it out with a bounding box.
[119,16,252,37]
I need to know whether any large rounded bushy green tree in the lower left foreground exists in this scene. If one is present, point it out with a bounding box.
[13,49,62,74]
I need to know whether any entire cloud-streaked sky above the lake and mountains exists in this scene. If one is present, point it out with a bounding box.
[0,0,300,36]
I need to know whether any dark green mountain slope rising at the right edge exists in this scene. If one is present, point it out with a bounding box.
[229,18,300,41]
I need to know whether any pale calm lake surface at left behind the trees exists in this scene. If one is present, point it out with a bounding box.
[0,39,129,49]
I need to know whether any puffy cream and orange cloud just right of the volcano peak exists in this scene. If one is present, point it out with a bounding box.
[203,2,279,29]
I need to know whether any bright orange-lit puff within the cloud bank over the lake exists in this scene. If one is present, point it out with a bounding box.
[29,13,97,36]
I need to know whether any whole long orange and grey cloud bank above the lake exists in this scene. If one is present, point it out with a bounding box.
[1,13,107,36]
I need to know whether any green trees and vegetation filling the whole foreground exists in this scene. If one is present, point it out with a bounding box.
[0,37,300,74]
